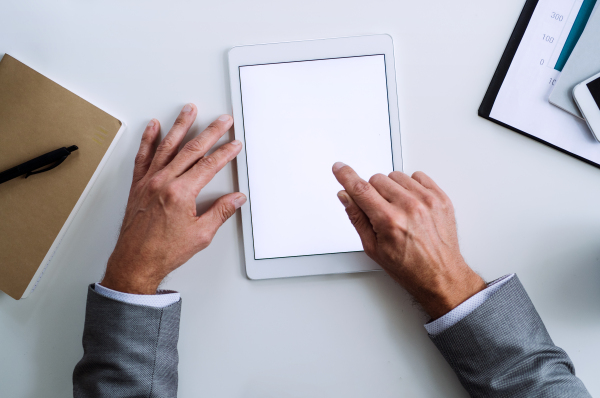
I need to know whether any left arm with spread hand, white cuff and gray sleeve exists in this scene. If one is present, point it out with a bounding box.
[73,104,246,397]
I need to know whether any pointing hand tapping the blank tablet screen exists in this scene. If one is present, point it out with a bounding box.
[333,162,486,319]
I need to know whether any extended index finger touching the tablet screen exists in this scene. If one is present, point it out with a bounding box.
[333,162,389,221]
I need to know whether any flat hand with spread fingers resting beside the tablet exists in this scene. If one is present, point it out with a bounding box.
[100,104,246,294]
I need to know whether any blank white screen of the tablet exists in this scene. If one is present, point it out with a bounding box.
[239,55,393,260]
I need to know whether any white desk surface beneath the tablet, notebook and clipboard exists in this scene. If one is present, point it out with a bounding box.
[0,0,600,398]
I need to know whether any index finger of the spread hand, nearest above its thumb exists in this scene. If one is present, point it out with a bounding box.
[181,140,242,195]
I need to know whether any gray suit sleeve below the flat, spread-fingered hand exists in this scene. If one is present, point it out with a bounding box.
[73,285,181,398]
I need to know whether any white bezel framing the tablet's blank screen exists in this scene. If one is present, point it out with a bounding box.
[228,34,402,279]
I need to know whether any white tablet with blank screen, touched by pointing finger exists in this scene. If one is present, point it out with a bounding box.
[229,35,402,279]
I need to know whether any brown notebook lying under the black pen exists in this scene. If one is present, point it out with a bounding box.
[0,54,123,299]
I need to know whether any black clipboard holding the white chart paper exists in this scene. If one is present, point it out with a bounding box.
[478,0,600,168]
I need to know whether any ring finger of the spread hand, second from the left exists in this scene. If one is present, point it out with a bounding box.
[148,104,198,174]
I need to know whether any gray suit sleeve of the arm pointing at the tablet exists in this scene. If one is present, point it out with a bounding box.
[430,275,590,398]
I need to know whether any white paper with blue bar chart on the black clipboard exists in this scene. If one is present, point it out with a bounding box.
[489,0,600,166]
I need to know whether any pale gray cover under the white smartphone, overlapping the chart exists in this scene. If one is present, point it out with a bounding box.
[548,7,600,119]
